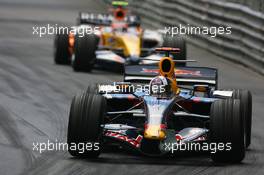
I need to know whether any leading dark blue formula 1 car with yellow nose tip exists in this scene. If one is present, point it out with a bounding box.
[68,48,252,163]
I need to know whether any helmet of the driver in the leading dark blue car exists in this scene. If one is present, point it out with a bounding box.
[149,76,173,98]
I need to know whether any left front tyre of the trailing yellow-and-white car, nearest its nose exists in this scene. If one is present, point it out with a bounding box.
[72,34,98,71]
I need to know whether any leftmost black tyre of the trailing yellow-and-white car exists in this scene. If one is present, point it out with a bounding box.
[54,34,71,64]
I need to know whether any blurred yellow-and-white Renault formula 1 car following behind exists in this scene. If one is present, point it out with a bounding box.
[54,1,186,71]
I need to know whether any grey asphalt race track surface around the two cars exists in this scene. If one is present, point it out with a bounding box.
[0,0,264,175]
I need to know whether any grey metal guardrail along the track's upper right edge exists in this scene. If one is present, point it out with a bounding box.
[130,0,264,74]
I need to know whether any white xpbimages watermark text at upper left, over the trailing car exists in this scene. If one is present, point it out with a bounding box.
[32,24,99,37]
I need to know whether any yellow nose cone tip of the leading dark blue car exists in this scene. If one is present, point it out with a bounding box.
[144,125,166,140]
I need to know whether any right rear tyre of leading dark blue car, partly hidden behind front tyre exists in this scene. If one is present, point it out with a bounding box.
[232,89,252,147]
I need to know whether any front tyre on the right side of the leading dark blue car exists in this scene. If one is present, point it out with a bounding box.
[210,99,246,163]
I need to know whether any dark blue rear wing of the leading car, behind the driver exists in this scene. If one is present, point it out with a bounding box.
[124,65,218,88]
